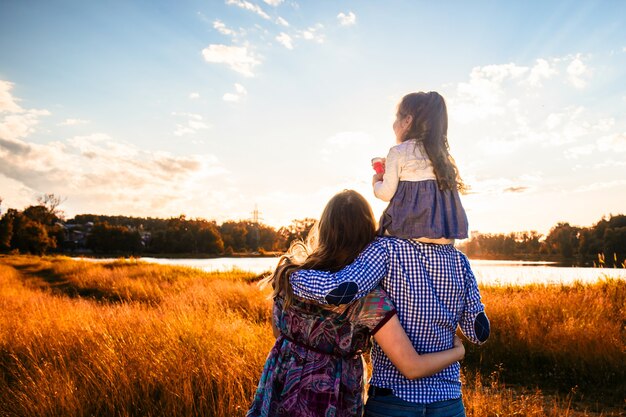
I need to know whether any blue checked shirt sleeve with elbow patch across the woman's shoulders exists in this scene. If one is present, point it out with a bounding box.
[289,238,389,305]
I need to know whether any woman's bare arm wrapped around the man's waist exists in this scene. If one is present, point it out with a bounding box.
[374,315,465,379]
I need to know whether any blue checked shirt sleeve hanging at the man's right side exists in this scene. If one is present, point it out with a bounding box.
[459,256,489,344]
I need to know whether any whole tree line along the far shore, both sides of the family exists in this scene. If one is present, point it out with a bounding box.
[0,194,626,266]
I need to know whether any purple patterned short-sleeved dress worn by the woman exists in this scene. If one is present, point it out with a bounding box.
[246,289,396,417]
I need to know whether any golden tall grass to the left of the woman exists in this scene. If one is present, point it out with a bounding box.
[0,258,272,416]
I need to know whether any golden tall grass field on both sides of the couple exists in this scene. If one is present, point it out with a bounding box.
[0,256,626,416]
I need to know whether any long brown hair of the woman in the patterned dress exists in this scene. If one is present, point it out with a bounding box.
[268,190,376,308]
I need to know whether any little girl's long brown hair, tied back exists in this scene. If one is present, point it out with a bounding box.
[398,91,466,191]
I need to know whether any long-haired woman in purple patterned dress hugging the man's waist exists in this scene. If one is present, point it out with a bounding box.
[247,190,465,417]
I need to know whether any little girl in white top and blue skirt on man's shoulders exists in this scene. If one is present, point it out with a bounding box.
[373,91,468,240]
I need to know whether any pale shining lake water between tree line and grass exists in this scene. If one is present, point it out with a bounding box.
[86,254,626,285]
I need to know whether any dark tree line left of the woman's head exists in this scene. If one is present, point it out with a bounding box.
[0,194,315,255]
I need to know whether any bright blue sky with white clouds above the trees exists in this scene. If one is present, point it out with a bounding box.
[0,0,626,234]
